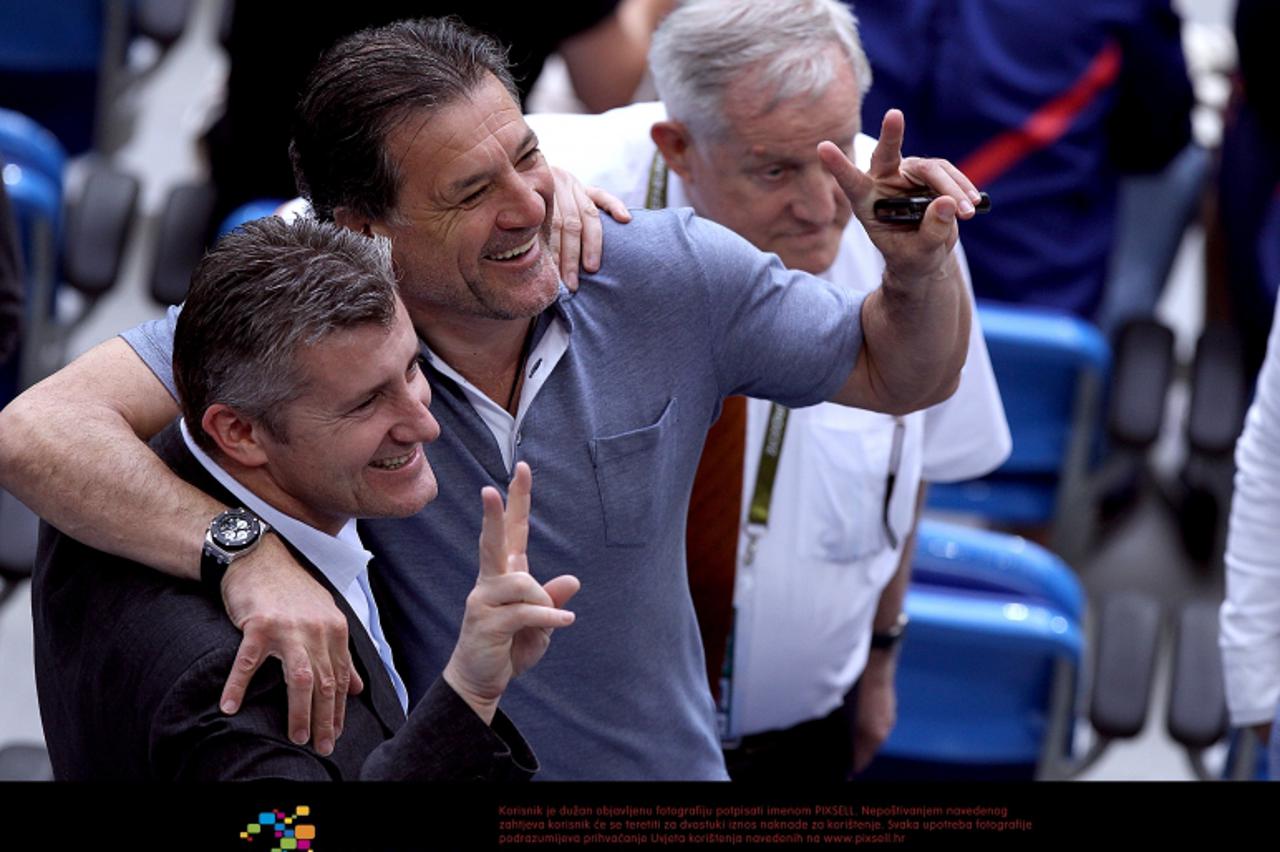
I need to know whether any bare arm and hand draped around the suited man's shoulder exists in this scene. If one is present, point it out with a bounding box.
[0,338,362,753]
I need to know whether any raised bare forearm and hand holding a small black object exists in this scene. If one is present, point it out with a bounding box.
[818,110,978,414]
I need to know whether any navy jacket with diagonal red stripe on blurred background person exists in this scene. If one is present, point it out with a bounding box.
[852,0,1204,326]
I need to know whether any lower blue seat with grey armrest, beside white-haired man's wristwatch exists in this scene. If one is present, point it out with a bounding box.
[867,521,1160,780]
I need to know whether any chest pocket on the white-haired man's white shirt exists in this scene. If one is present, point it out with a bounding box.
[800,406,920,580]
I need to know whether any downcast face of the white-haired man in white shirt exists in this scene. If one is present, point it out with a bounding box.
[673,52,861,272]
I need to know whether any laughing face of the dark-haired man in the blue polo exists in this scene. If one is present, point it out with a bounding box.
[371,75,559,327]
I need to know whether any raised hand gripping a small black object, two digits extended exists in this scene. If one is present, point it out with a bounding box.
[818,110,979,278]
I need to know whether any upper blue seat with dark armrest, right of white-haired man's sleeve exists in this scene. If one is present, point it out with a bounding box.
[929,301,1174,562]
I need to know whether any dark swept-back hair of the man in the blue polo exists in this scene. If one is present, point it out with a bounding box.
[289,18,520,221]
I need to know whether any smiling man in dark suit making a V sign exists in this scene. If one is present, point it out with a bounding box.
[33,219,577,780]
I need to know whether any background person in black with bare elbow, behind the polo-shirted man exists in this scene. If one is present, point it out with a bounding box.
[205,0,673,221]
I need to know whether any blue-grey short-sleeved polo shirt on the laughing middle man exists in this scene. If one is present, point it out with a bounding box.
[124,210,861,780]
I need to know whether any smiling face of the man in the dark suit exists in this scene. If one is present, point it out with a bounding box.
[257,301,440,532]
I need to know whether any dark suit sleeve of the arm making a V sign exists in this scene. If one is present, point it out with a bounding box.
[150,649,538,782]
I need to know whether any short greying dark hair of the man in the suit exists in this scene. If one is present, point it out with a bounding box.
[173,216,396,453]
